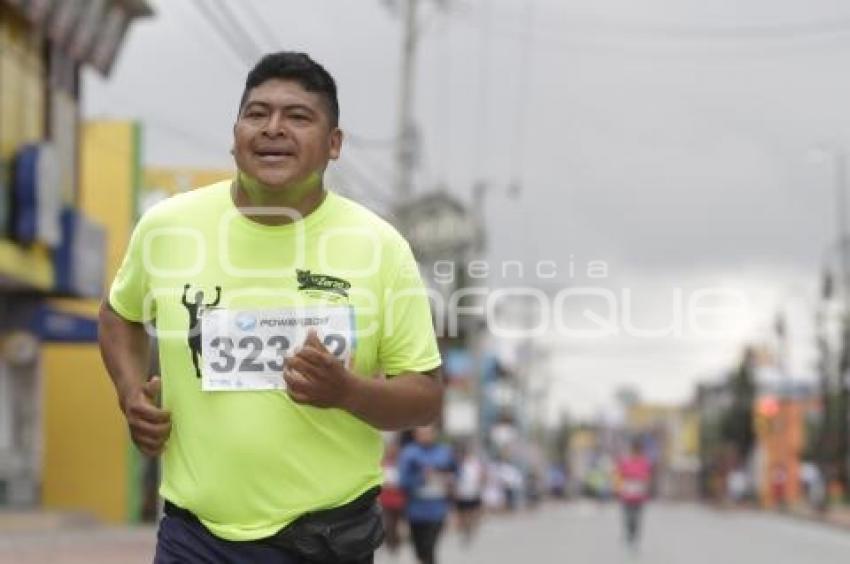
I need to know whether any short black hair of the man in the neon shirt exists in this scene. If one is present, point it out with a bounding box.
[239,51,339,127]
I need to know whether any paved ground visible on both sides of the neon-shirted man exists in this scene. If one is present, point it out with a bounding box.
[0,502,850,564]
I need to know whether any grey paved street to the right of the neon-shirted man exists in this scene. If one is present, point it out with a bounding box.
[378,502,850,564]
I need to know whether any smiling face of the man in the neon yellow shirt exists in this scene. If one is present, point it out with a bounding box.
[233,79,342,190]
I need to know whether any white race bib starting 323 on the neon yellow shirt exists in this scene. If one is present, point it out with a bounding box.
[201,307,354,392]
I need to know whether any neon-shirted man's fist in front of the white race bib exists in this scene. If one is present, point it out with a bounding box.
[283,329,357,409]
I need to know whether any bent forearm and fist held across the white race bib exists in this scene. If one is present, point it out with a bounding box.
[283,331,443,431]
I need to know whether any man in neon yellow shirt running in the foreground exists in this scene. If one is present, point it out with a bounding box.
[100,52,443,564]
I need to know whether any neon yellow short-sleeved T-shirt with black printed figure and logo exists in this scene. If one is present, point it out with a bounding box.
[109,181,440,540]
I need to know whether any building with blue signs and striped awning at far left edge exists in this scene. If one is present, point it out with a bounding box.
[0,0,151,507]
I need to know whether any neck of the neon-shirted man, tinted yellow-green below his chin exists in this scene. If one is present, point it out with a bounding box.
[231,172,327,225]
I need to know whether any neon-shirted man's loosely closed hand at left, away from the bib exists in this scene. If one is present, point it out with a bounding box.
[121,376,171,456]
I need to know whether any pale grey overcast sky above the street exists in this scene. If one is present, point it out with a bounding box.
[84,0,850,416]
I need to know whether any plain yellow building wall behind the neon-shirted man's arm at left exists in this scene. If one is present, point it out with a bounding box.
[42,122,139,522]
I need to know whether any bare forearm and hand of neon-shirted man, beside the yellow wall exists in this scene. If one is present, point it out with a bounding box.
[98,300,171,456]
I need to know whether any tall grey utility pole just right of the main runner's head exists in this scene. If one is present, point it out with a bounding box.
[396,0,419,203]
